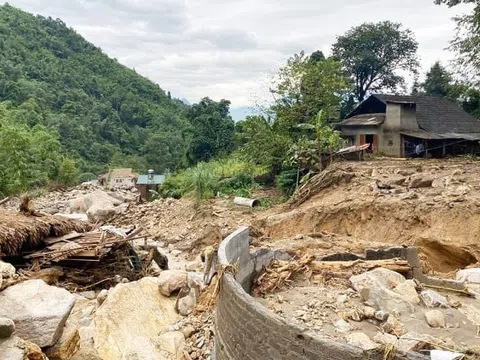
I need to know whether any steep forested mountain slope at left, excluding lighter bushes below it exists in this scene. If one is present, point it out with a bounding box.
[0,5,188,173]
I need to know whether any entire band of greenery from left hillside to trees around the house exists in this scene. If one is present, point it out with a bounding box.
[0,0,480,200]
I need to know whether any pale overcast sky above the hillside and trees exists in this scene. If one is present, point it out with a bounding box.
[4,0,472,112]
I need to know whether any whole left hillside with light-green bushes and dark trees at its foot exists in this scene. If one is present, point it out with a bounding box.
[0,4,234,194]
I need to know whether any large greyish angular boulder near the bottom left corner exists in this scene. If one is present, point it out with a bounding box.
[0,280,75,347]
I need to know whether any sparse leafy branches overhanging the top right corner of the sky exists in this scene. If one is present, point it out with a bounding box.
[435,0,480,80]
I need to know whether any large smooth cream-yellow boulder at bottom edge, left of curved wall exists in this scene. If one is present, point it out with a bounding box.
[93,277,181,359]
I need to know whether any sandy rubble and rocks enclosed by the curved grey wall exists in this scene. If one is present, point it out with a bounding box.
[256,260,480,359]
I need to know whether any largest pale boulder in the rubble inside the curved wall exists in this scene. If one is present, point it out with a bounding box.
[350,268,414,314]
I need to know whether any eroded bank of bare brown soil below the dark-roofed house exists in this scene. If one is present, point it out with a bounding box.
[254,159,480,273]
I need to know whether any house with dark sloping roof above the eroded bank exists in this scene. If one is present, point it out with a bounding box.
[337,95,480,157]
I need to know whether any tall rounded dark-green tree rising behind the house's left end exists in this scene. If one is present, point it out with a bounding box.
[332,21,419,101]
